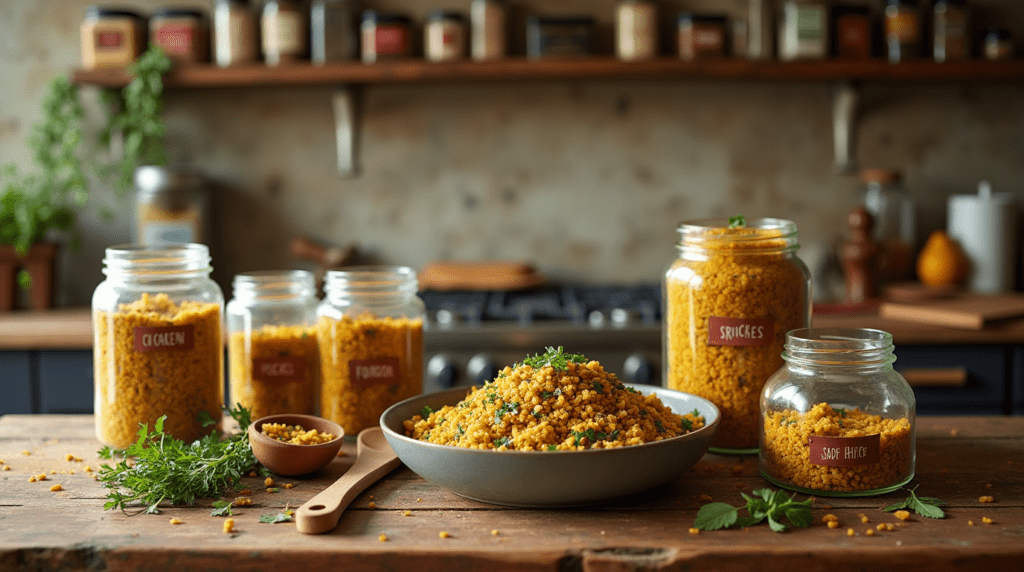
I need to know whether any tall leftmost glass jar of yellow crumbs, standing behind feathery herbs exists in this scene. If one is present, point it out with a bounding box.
[92,245,224,448]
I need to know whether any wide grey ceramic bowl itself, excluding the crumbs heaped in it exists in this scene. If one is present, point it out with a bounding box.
[381,384,720,508]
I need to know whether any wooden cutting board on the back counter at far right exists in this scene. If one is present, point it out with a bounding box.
[879,294,1024,329]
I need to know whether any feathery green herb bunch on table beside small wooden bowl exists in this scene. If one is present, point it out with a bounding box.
[98,405,268,514]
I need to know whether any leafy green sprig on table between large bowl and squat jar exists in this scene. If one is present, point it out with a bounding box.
[693,488,814,532]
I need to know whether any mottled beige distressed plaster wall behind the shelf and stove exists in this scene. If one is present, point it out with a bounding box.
[0,0,1024,304]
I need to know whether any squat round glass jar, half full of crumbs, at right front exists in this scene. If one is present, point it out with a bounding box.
[760,328,915,496]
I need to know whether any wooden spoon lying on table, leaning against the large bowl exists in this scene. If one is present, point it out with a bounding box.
[295,427,401,534]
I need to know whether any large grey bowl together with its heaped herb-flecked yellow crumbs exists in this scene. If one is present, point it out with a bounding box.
[381,349,719,508]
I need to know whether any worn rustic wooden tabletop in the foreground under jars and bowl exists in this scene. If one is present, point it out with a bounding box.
[0,415,1024,572]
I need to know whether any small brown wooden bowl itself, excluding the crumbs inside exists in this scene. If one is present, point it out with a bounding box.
[249,413,345,477]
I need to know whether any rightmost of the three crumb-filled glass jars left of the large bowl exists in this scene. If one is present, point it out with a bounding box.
[316,266,426,435]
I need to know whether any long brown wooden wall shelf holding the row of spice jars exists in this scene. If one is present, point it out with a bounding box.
[73,57,1024,88]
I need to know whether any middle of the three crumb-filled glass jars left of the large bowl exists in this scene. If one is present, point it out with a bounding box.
[227,270,319,420]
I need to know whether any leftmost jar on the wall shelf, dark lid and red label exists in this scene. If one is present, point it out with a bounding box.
[80,6,145,70]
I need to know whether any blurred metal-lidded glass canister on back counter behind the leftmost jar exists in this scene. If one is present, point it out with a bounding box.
[135,166,208,246]
